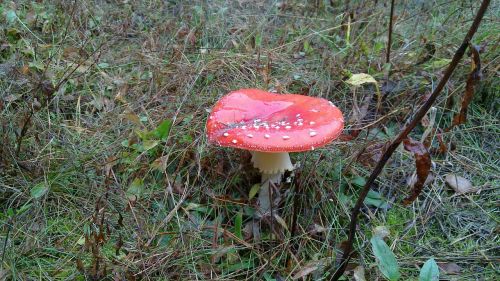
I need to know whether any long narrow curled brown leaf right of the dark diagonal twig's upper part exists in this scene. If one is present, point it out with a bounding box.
[447,44,481,131]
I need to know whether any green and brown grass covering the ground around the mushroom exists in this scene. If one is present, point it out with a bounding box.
[0,0,500,280]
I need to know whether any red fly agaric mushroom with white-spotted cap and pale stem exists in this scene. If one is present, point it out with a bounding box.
[207,89,344,215]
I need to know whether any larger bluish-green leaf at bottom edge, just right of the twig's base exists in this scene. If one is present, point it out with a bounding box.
[370,236,401,281]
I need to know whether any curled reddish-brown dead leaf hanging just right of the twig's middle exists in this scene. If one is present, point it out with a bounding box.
[403,138,431,205]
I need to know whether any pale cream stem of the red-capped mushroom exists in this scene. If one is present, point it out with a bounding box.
[251,151,293,216]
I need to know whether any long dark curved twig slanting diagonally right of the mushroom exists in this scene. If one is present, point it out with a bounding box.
[330,0,490,281]
